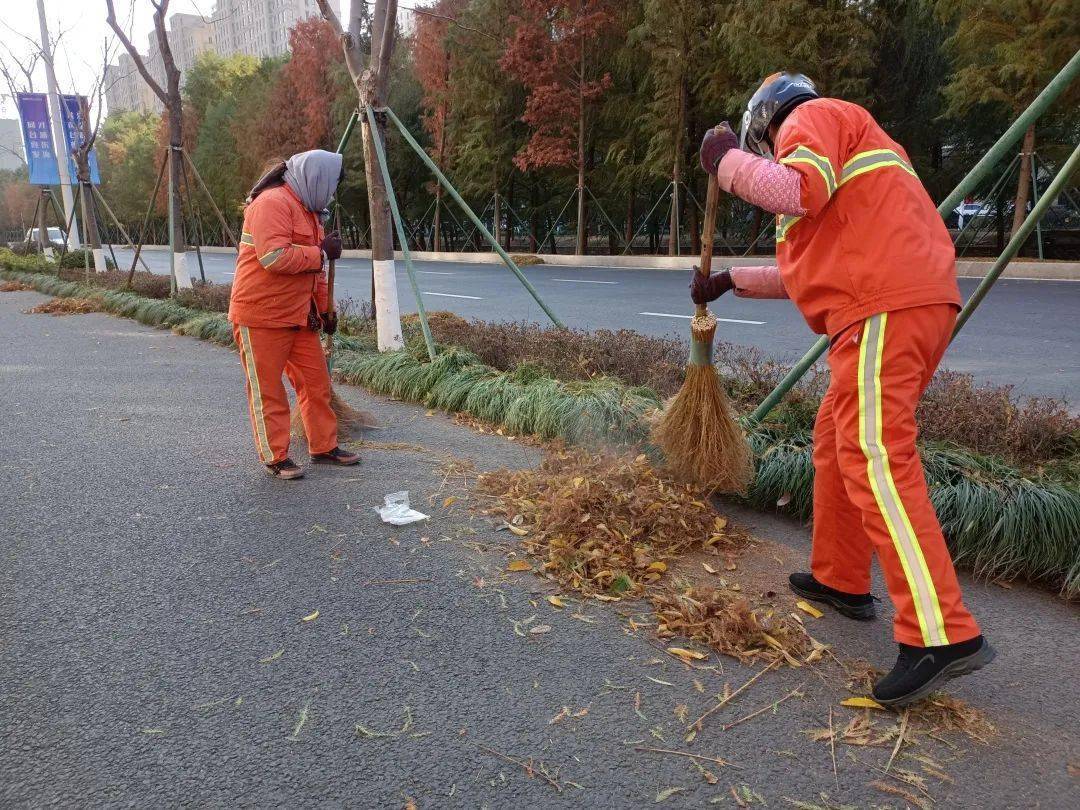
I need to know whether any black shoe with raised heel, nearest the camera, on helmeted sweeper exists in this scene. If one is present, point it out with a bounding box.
[873,636,997,706]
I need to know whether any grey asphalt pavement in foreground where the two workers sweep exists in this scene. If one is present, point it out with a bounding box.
[0,293,1080,809]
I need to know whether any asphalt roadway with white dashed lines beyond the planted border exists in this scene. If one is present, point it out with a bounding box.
[118,252,1080,404]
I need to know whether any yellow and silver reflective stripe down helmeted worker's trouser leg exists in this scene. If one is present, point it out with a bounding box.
[859,312,948,647]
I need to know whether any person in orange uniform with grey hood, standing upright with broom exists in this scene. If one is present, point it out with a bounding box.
[229,149,360,478]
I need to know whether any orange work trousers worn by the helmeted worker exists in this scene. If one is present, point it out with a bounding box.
[810,303,980,647]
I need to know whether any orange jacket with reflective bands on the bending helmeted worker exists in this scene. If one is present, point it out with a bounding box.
[775,98,960,335]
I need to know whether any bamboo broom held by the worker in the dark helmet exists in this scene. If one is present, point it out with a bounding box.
[652,175,754,492]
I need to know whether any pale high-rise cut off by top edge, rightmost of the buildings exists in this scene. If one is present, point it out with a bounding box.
[212,0,340,57]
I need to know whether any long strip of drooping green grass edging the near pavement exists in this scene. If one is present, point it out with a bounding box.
[0,257,1080,598]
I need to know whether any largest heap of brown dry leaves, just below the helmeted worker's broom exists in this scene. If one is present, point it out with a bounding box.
[476,449,741,598]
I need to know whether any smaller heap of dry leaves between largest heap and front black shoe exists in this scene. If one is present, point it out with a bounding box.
[651,588,825,666]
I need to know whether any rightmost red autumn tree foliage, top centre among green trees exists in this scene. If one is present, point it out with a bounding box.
[500,0,615,172]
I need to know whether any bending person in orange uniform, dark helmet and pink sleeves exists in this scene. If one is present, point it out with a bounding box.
[691,73,995,705]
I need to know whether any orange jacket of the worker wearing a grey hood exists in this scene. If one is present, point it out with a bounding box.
[229,186,326,327]
